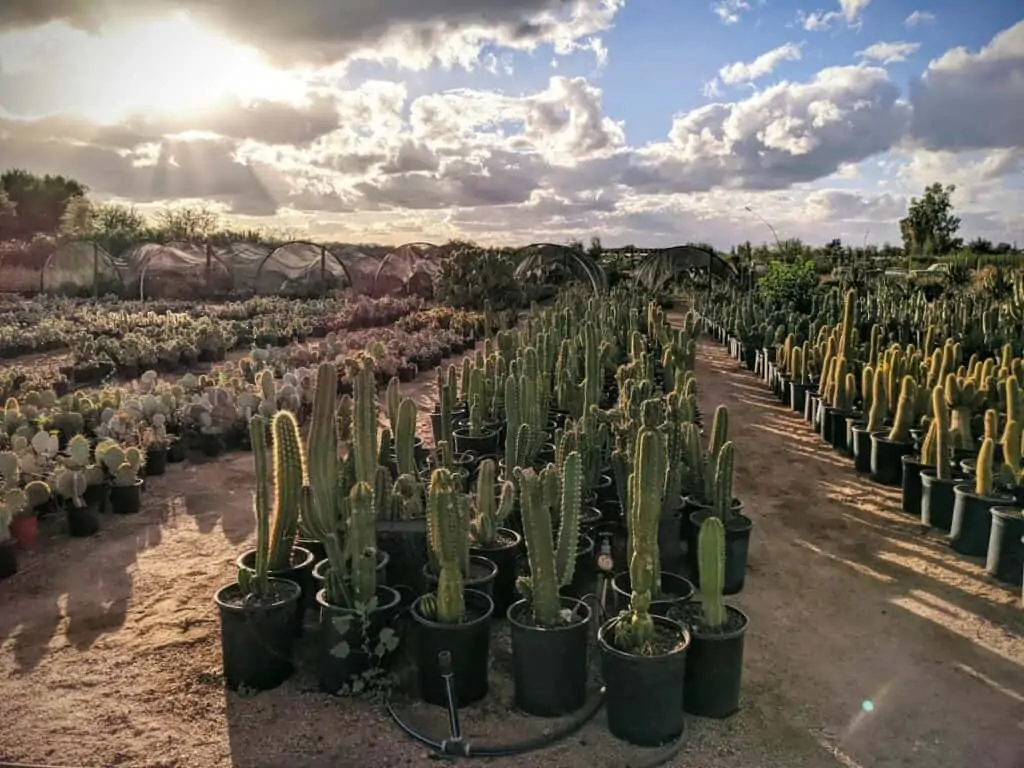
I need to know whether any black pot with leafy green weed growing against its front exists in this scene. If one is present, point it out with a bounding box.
[316,585,401,693]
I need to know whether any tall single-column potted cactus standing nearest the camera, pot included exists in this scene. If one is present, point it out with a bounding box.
[597,426,690,746]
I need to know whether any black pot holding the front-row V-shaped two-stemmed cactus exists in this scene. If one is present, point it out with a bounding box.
[508,597,591,717]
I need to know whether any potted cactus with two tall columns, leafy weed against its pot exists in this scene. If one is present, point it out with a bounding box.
[301,364,401,693]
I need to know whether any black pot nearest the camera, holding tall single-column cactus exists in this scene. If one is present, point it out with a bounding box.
[597,615,690,746]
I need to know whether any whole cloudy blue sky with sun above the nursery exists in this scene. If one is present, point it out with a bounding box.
[0,0,1024,248]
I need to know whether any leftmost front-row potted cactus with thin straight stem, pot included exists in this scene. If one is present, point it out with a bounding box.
[214,417,302,690]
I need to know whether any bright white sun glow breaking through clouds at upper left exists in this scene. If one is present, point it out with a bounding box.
[5,12,296,123]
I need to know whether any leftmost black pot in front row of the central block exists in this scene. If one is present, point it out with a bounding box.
[213,579,302,690]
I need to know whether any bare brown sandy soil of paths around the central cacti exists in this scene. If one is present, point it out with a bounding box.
[0,335,1024,768]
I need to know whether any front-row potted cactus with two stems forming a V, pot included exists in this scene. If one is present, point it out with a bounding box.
[508,451,591,717]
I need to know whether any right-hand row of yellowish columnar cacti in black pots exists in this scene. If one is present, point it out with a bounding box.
[706,292,1024,598]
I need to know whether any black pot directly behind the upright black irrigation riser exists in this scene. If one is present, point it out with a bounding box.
[411,590,495,707]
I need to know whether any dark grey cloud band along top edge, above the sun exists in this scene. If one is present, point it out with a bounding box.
[0,0,624,69]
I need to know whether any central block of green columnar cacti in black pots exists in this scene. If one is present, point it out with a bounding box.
[216,291,751,745]
